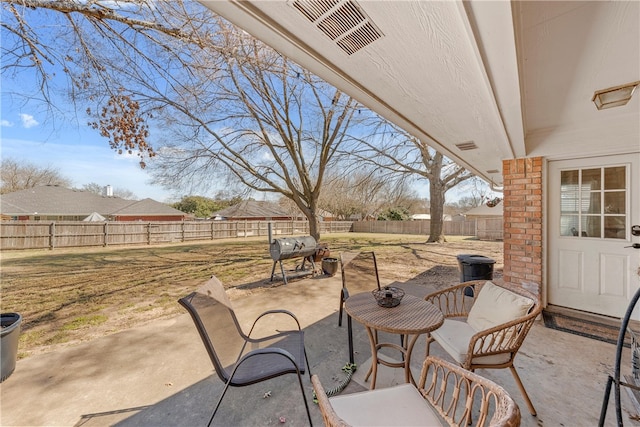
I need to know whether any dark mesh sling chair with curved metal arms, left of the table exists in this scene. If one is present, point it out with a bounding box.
[179,276,312,425]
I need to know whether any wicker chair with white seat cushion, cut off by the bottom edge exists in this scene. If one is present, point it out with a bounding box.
[311,356,520,427]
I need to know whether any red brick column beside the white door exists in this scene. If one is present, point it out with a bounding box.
[502,157,543,286]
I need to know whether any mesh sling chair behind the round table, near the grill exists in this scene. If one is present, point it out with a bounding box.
[338,251,380,364]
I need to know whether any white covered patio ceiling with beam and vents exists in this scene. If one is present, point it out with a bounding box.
[201,0,640,185]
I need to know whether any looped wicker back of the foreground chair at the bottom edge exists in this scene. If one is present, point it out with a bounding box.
[418,356,520,427]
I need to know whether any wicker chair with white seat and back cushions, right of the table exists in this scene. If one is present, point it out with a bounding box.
[425,280,542,415]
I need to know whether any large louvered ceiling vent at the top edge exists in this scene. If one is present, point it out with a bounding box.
[292,0,383,55]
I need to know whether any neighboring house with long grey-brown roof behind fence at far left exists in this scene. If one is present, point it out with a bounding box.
[0,185,187,221]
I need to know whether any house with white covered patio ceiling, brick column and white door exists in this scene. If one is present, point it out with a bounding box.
[203,0,640,320]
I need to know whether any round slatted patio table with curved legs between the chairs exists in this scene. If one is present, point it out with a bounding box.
[344,292,444,390]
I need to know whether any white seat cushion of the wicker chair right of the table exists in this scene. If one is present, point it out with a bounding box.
[431,319,510,365]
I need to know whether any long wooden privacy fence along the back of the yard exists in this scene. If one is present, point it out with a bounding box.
[0,218,503,250]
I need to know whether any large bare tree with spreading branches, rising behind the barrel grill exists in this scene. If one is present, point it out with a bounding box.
[145,20,367,239]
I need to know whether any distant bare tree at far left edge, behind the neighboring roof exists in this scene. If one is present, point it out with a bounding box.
[0,158,71,194]
